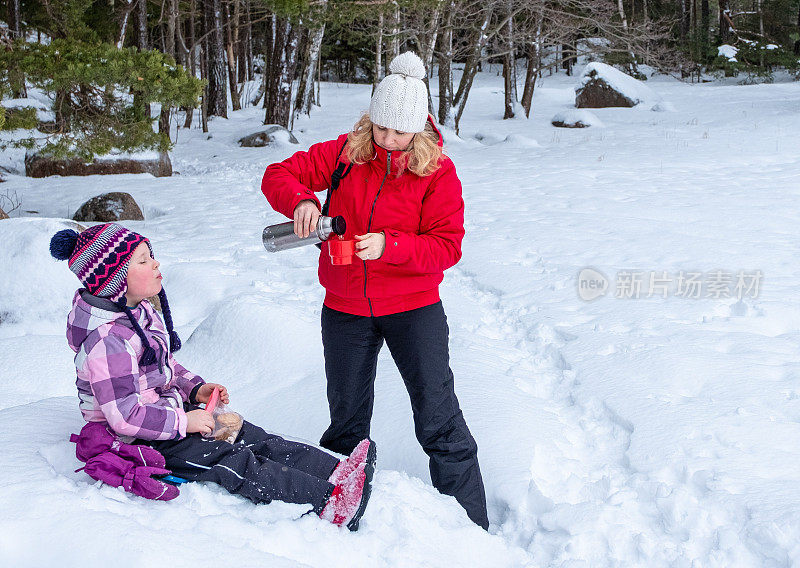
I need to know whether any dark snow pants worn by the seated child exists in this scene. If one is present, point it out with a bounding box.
[148,412,339,514]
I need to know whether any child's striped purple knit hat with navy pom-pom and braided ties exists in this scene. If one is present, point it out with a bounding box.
[50,223,181,365]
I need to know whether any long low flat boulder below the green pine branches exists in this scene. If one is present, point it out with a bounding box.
[25,152,172,178]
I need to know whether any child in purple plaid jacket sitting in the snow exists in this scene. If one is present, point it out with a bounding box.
[50,223,375,530]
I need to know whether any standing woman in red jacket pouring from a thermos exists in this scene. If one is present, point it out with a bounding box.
[261,52,489,528]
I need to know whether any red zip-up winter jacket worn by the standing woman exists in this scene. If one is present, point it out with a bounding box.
[261,118,464,316]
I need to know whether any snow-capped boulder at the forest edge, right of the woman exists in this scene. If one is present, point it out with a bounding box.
[575,62,661,108]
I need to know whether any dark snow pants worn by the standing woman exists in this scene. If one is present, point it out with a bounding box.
[320,302,489,529]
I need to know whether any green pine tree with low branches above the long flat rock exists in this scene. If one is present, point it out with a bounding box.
[0,39,203,160]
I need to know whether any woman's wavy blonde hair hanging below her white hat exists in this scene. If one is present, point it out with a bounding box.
[347,114,444,177]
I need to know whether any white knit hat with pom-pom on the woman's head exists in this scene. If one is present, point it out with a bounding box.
[369,51,428,132]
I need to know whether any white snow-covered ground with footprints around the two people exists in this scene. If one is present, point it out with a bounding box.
[0,64,800,568]
